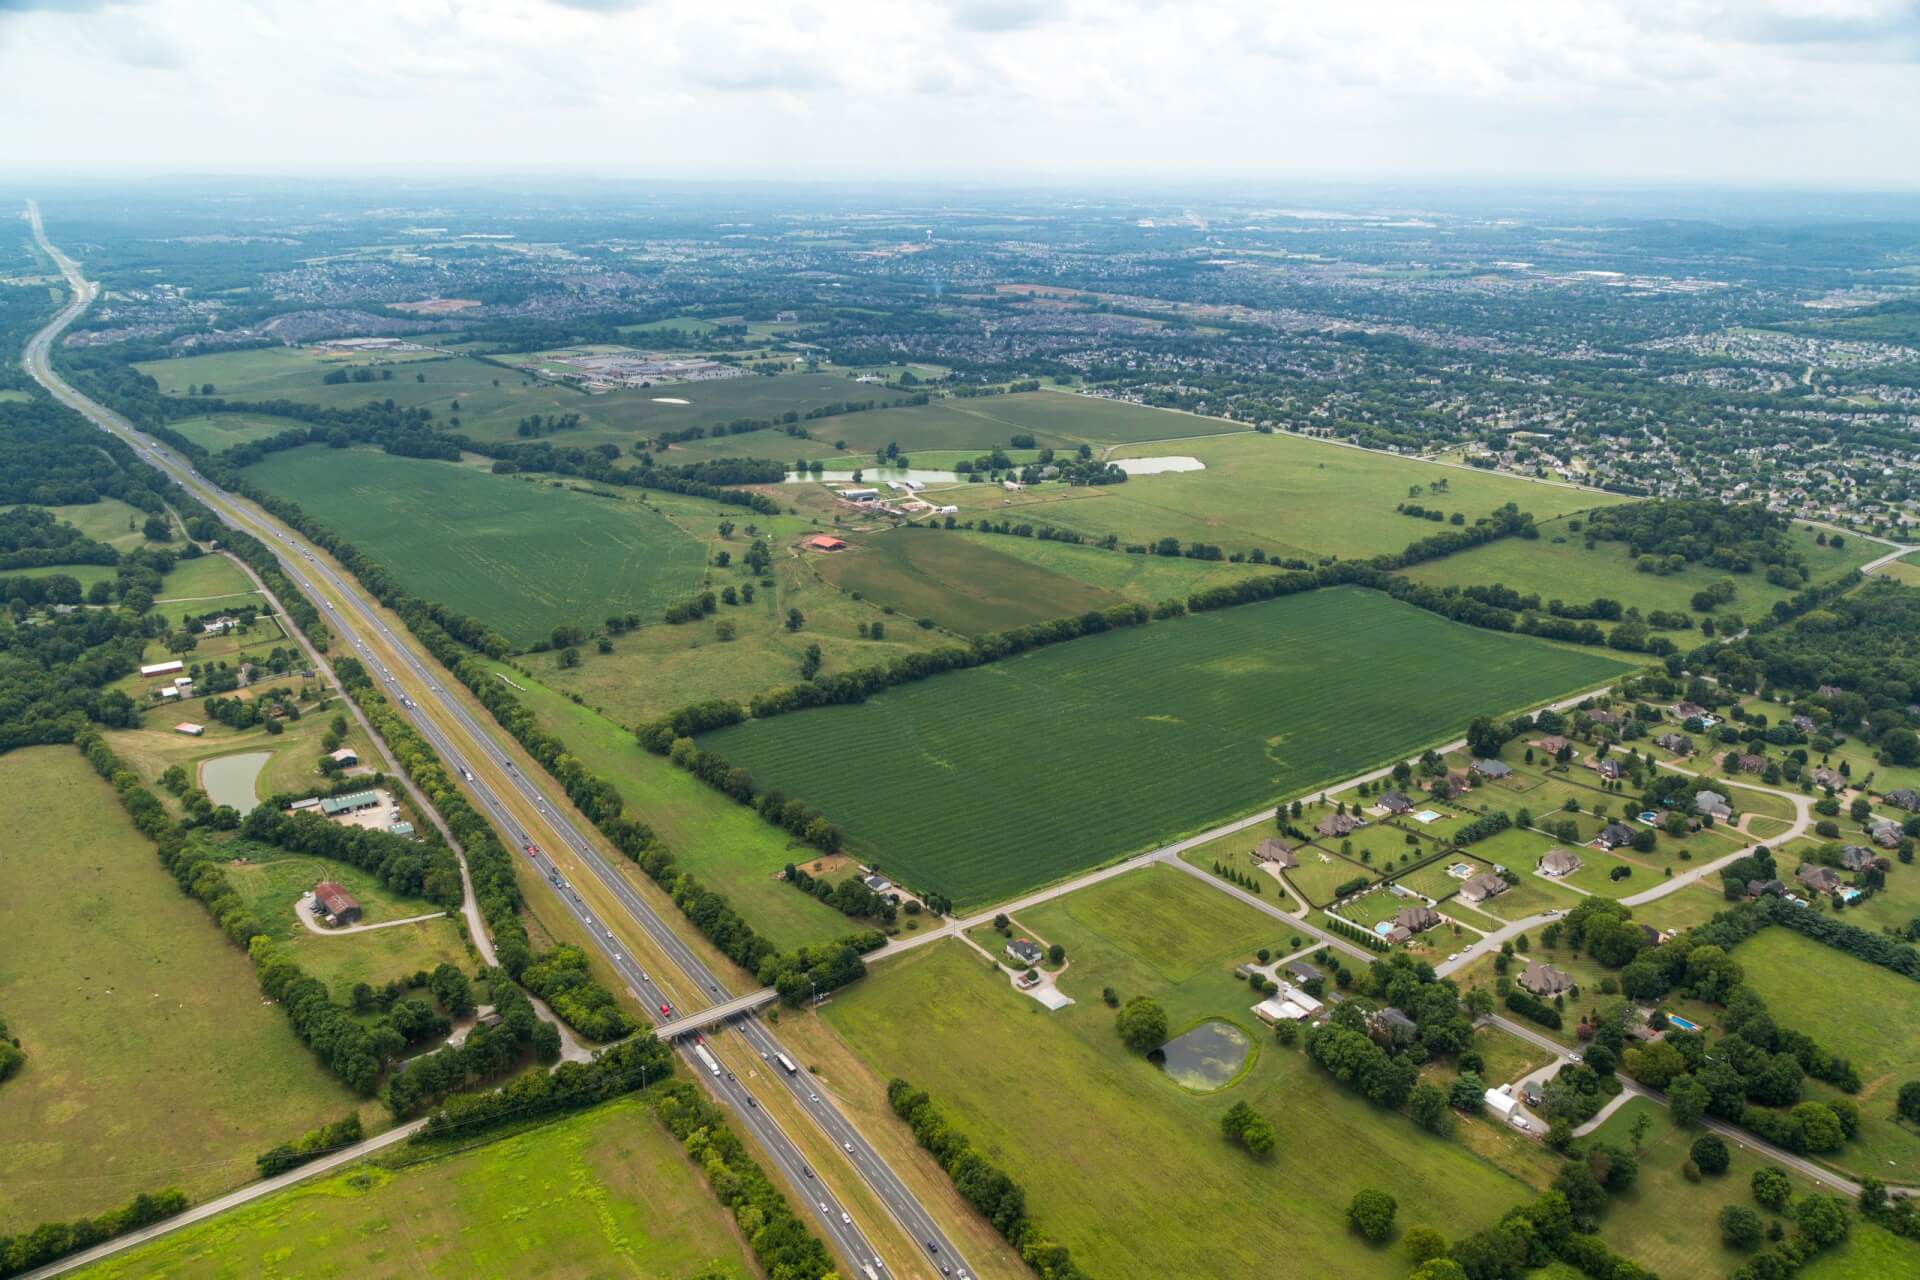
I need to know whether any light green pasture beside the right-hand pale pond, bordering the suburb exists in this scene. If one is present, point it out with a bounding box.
[975,433,1613,558]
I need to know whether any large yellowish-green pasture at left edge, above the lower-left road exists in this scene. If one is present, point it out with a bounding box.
[0,747,364,1234]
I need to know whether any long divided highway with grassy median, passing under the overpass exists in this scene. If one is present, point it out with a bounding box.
[25,203,968,1274]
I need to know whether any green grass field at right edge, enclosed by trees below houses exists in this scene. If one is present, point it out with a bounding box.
[1734,924,1920,1182]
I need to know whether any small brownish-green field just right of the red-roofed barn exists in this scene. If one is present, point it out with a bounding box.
[816,530,1121,635]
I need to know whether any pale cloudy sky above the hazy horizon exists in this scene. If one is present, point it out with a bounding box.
[0,0,1920,188]
